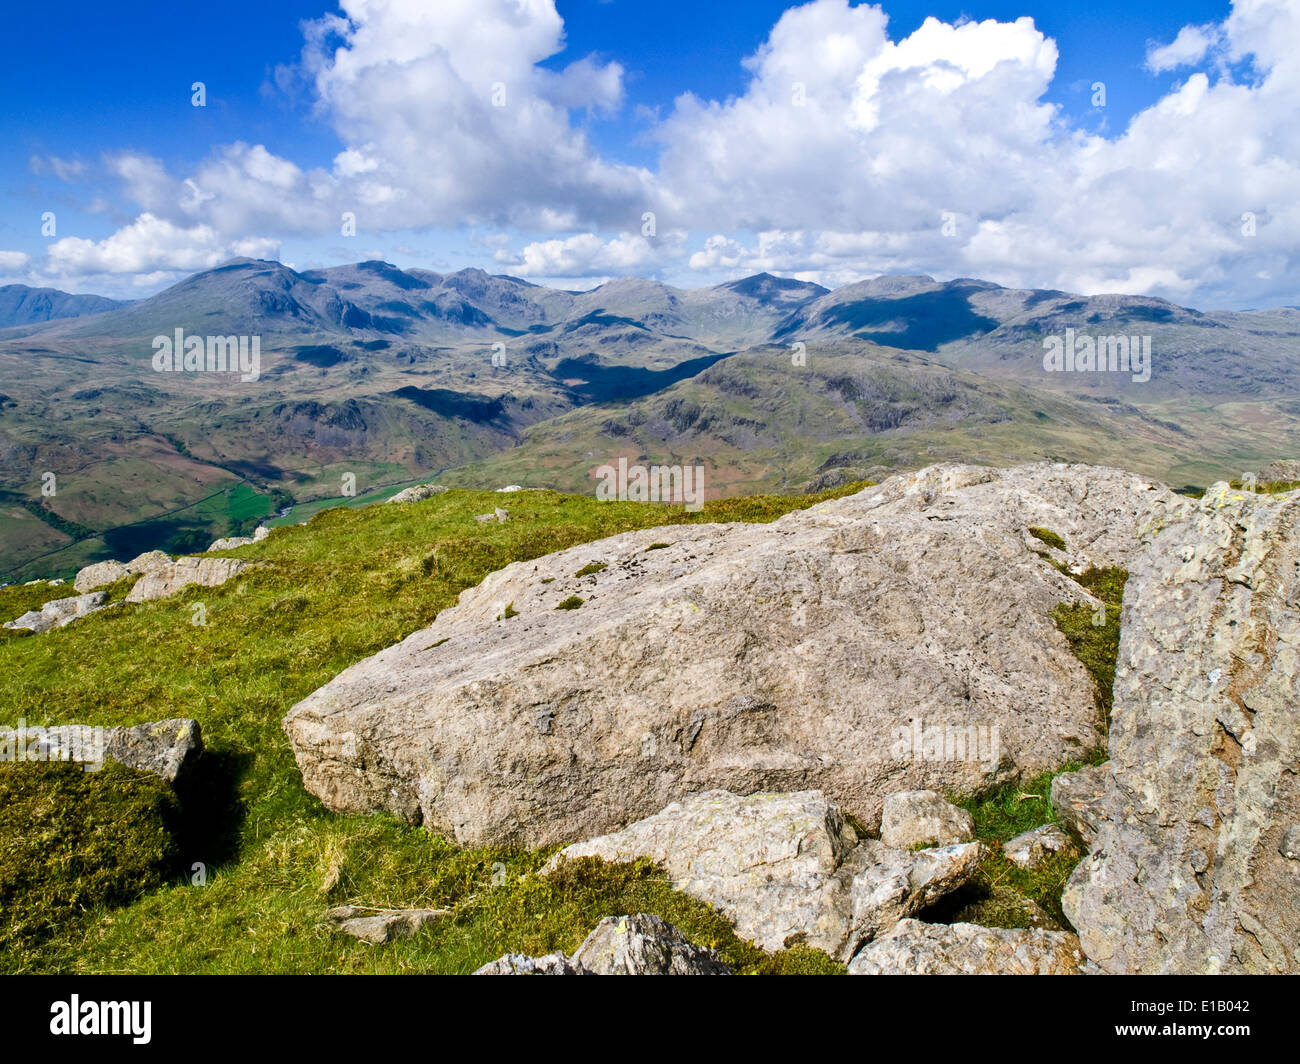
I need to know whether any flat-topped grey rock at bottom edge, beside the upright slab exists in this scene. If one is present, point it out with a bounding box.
[849,920,1084,976]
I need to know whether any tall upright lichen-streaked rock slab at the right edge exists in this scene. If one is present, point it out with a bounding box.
[1062,484,1300,973]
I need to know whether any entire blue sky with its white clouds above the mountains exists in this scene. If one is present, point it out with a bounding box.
[0,0,1300,306]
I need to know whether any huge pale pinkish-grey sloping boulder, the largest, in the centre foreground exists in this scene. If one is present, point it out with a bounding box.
[285,464,1174,847]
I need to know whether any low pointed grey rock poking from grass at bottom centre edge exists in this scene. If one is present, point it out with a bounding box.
[475,913,732,976]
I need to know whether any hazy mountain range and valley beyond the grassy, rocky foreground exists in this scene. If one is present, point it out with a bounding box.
[0,259,1300,572]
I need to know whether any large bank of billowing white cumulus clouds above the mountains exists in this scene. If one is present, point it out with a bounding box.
[17,0,1300,304]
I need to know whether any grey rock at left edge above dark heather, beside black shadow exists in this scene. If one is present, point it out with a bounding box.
[18,717,203,783]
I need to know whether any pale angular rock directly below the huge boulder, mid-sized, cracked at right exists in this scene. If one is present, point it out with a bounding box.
[547,791,982,960]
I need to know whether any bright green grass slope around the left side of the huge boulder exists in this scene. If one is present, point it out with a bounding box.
[0,484,865,972]
